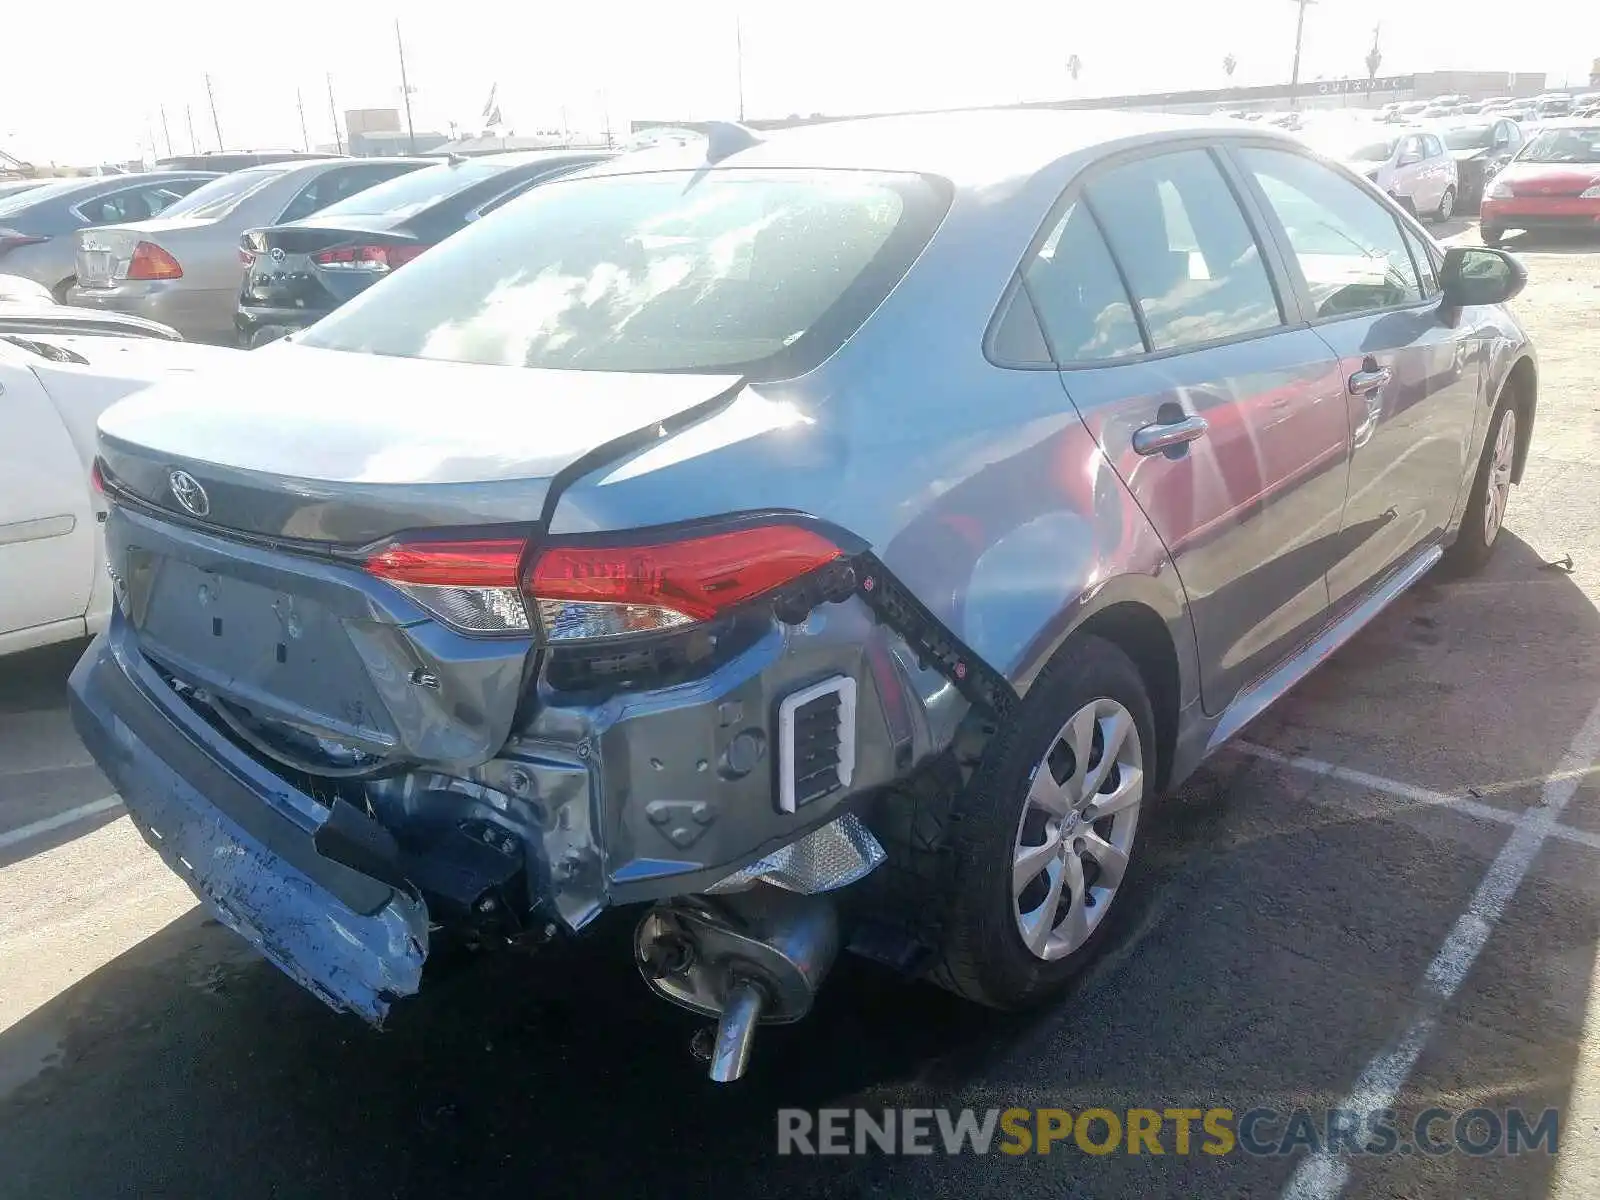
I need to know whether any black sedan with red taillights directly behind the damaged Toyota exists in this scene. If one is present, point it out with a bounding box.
[234,150,610,346]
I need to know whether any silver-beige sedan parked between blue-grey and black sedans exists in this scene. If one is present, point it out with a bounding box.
[66,158,437,346]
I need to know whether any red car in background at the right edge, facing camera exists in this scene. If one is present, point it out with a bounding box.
[1478,120,1600,246]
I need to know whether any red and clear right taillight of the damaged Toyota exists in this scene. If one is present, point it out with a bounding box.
[365,525,842,642]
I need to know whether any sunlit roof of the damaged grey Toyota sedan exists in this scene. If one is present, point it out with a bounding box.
[597,109,1299,186]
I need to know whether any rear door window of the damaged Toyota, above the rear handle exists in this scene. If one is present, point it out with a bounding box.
[1088,150,1283,350]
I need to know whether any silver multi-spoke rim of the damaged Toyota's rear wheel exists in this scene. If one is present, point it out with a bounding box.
[1011,698,1144,962]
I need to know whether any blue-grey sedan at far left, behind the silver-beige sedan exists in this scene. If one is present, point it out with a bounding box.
[0,171,216,299]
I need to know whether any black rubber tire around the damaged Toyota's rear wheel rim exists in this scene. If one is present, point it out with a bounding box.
[931,637,1157,1008]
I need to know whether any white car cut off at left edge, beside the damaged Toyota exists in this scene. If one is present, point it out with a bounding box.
[0,299,240,656]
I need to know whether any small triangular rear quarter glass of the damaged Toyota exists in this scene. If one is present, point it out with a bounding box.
[1017,203,1144,363]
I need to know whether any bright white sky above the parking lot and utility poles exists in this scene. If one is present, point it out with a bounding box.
[0,0,1600,163]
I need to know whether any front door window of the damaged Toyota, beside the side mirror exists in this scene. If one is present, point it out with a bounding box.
[1238,147,1422,317]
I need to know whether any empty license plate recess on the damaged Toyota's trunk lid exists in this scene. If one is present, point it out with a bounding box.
[136,558,397,752]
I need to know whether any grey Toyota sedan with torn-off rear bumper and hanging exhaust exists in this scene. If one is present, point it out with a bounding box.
[72,114,1536,1080]
